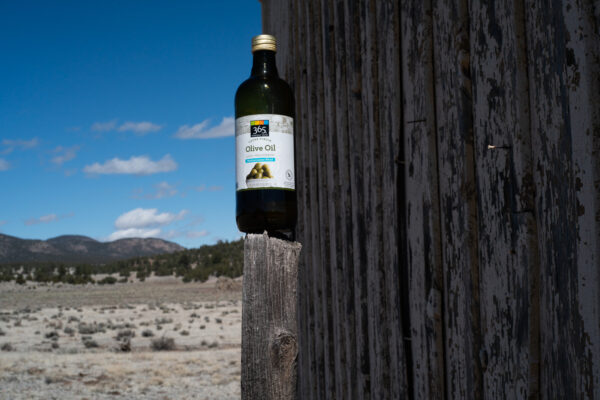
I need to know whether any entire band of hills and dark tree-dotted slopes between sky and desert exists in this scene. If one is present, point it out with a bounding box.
[0,235,244,284]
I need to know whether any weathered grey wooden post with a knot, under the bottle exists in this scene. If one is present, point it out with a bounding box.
[242,233,302,400]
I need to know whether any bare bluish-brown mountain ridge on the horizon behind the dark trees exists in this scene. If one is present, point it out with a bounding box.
[0,234,184,264]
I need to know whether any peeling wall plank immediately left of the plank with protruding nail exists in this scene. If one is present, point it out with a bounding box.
[433,0,483,399]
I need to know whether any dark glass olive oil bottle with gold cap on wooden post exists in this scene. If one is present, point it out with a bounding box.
[235,35,296,239]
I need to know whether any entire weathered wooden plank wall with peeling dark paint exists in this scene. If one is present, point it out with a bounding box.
[262,0,600,400]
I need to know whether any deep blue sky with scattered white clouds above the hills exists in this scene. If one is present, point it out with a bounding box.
[0,0,261,247]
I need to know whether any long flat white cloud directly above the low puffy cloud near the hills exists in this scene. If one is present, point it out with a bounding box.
[83,154,177,175]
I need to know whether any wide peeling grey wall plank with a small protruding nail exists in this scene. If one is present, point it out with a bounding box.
[469,0,539,399]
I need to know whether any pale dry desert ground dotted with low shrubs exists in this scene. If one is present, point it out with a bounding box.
[0,277,242,400]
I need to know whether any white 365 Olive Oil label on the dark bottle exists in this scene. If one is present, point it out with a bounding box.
[235,114,296,190]
